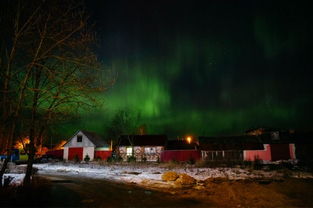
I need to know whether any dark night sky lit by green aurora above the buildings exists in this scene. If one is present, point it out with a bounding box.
[57,0,313,136]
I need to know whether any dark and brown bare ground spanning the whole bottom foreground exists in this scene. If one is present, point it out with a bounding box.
[0,175,313,207]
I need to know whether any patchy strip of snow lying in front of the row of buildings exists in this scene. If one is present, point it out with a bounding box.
[34,163,313,184]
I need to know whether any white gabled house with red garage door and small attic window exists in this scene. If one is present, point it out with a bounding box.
[63,130,111,160]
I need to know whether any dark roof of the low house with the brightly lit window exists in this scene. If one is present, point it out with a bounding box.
[119,135,167,146]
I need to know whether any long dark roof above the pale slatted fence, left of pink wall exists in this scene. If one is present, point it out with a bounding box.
[199,135,264,150]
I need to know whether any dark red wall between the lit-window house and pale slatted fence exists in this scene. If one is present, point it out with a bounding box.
[161,150,201,162]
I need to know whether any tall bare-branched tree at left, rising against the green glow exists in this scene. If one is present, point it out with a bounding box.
[1,0,113,184]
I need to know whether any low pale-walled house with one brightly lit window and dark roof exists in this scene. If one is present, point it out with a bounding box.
[117,135,167,161]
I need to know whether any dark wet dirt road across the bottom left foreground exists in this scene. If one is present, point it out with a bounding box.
[0,176,210,207]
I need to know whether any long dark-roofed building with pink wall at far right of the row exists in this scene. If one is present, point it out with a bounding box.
[199,131,296,161]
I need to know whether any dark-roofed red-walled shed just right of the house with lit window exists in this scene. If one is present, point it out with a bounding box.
[161,140,201,162]
